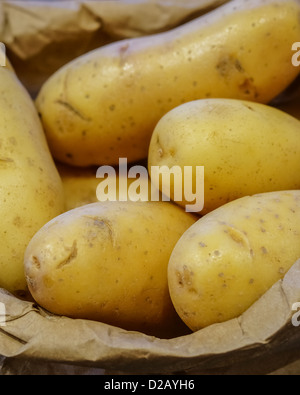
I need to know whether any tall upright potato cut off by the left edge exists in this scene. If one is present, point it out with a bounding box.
[0,67,64,296]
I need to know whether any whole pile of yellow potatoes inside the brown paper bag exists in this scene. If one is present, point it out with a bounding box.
[0,0,300,338]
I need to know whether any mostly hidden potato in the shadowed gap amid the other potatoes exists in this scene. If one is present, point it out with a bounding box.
[57,163,157,211]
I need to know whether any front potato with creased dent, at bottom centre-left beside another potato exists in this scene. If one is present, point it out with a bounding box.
[24,202,195,337]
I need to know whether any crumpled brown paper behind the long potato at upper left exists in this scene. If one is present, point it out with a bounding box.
[0,0,229,96]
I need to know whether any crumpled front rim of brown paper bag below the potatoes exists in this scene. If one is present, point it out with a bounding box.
[0,260,300,374]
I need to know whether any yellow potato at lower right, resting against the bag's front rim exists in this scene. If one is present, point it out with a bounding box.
[168,190,300,331]
